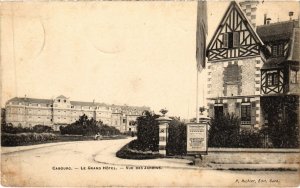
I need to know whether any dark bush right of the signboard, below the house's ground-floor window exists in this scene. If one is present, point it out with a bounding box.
[208,114,240,147]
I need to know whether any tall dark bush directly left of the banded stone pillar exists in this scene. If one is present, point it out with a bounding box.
[137,111,159,151]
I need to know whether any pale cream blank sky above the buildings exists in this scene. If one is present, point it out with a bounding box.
[0,1,299,118]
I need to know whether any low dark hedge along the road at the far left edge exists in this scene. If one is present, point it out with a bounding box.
[1,133,57,146]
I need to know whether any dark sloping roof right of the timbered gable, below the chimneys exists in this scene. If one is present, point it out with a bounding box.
[256,20,299,42]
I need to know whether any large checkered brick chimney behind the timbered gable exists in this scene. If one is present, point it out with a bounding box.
[240,0,259,29]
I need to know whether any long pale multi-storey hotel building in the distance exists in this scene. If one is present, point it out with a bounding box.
[5,95,150,132]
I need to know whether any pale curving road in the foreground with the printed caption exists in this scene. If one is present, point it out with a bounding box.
[1,139,299,187]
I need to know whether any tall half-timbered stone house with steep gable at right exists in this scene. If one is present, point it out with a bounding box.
[207,1,300,129]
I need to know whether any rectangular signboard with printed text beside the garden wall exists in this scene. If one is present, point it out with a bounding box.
[187,123,207,155]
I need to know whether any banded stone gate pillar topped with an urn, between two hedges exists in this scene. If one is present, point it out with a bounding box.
[157,116,171,156]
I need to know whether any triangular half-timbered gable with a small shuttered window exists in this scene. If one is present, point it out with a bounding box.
[207,1,262,61]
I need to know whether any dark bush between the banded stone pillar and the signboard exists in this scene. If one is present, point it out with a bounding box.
[166,119,187,155]
